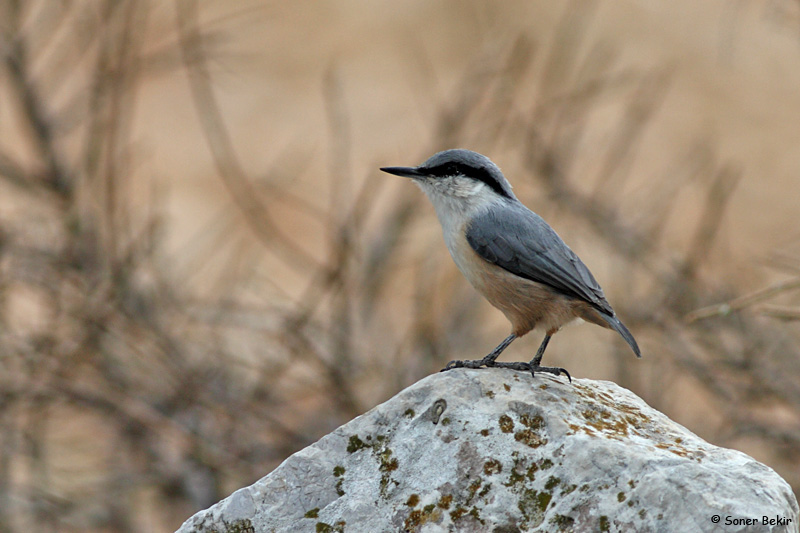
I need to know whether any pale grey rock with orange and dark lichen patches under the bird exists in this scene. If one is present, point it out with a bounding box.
[178,369,798,533]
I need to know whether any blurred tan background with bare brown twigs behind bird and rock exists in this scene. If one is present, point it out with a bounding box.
[0,0,800,532]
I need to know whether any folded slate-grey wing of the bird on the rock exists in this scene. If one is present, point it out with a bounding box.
[466,205,614,316]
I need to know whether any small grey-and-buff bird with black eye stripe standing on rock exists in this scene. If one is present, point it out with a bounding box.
[380,149,642,382]
